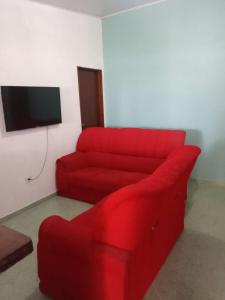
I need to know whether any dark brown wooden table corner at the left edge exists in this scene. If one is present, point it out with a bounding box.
[0,225,33,272]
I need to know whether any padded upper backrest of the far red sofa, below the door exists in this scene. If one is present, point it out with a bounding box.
[77,127,185,159]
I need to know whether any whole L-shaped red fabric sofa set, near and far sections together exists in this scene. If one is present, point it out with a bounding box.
[38,128,200,300]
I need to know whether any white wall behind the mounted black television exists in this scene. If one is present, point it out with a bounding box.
[0,0,102,218]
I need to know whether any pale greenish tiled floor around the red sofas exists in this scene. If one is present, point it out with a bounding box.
[0,181,225,300]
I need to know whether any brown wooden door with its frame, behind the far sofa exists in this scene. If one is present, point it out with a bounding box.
[77,67,104,130]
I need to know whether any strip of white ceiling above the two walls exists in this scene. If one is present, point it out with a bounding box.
[30,0,160,17]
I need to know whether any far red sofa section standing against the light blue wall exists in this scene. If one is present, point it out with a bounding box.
[56,128,185,203]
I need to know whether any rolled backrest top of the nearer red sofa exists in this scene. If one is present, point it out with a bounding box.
[94,145,200,250]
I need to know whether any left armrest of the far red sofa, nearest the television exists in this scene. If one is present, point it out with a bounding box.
[56,152,88,171]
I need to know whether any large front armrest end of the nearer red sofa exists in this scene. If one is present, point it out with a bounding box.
[38,216,132,300]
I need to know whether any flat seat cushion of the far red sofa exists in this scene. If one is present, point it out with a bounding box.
[68,167,149,192]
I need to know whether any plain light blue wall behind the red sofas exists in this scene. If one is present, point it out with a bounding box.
[103,0,225,182]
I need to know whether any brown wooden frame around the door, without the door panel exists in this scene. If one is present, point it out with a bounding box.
[77,66,104,127]
